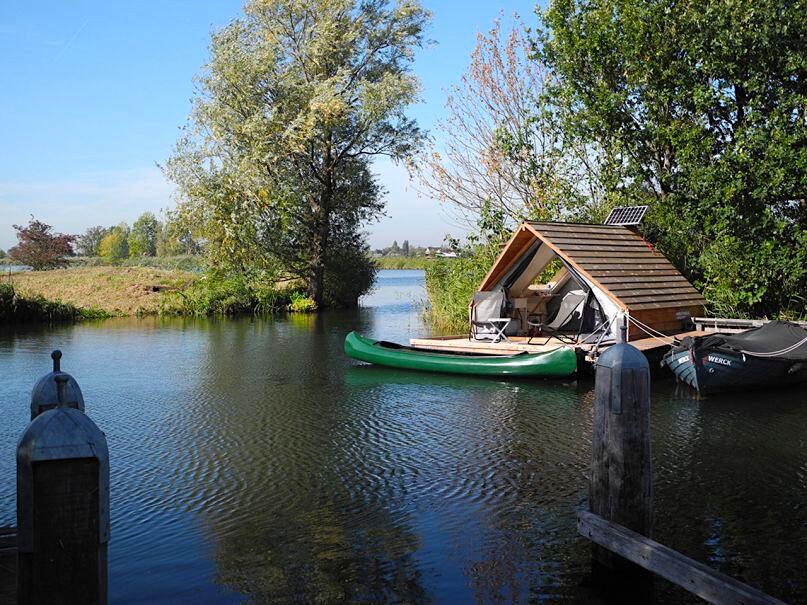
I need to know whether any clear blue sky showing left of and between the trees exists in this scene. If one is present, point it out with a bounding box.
[0,0,535,249]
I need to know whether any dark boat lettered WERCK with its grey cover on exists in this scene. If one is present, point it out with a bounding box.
[662,321,807,395]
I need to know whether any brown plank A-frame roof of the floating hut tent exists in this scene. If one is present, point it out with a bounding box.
[479,222,706,311]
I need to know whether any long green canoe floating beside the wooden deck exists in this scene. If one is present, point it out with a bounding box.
[345,332,577,378]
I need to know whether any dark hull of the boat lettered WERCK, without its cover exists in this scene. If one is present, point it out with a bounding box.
[664,347,807,395]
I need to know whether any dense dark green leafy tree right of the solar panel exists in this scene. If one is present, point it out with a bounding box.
[538,0,807,315]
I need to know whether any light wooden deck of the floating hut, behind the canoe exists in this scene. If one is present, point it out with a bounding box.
[409,330,703,357]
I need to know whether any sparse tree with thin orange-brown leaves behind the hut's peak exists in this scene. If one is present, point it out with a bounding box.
[415,19,603,228]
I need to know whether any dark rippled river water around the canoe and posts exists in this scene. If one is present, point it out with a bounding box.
[0,271,807,605]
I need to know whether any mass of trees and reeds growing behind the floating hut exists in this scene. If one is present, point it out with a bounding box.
[418,0,807,322]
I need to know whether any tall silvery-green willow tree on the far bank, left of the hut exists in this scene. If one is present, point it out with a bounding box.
[166,0,428,305]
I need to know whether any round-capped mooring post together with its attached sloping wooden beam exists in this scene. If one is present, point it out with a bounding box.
[577,342,785,605]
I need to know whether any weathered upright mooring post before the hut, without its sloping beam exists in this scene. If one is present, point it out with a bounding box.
[589,343,653,572]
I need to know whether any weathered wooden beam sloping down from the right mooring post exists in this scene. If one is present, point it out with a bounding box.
[577,511,785,605]
